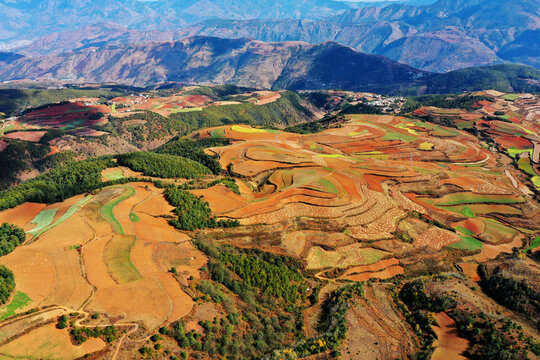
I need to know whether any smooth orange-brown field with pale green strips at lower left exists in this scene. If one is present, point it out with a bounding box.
[0,183,205,358]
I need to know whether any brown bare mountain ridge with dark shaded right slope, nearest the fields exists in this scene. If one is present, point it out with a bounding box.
[0,36,540,94]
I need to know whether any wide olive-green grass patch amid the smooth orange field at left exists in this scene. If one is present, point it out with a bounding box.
[103,235,143,284]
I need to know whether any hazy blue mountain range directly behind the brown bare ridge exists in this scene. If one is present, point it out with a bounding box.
[8,0,540,72]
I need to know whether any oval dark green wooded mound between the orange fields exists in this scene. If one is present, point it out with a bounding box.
[117,152,211,179]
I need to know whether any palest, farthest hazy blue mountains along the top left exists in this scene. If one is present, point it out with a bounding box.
[0,0,351,42]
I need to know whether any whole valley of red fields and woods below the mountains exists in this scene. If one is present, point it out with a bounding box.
[0,86,540,359]
